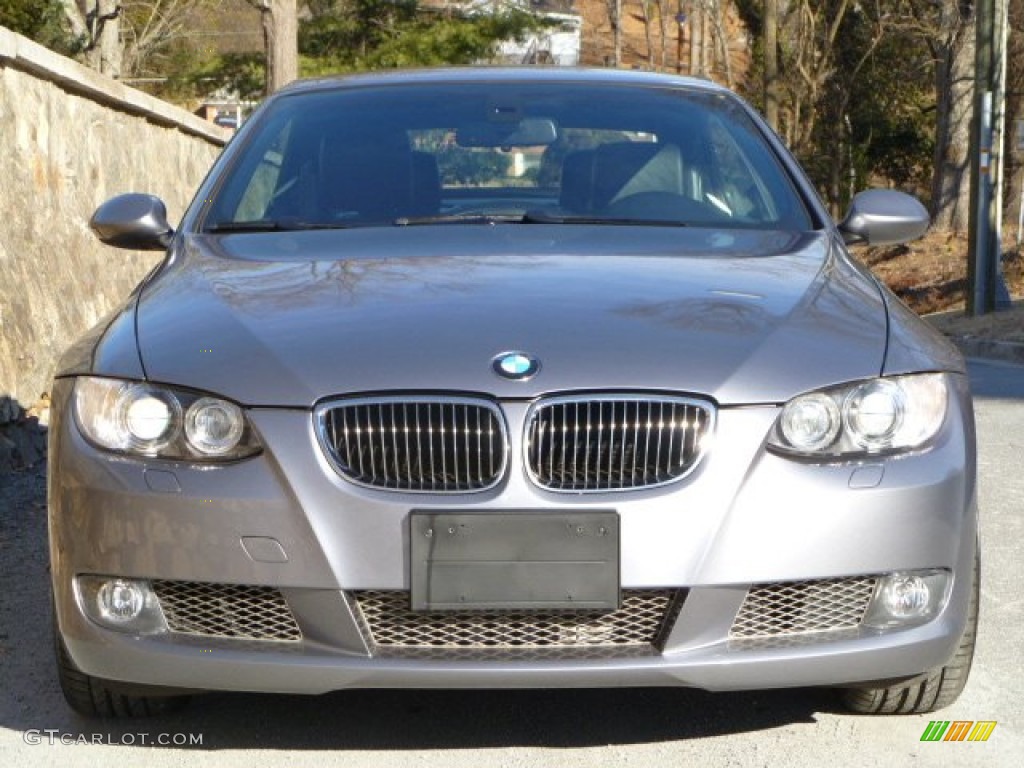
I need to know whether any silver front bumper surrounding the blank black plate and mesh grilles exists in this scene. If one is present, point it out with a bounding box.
[50,380,977,693]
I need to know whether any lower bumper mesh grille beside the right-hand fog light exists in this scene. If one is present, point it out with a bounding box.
[729,577,878,639]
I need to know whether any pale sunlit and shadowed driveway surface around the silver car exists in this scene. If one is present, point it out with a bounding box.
[0,364,1024,768]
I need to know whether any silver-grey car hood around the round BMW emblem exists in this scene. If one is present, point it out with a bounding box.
[137,225,886,407]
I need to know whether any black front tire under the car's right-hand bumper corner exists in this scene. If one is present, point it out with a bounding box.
[840,548,981,715]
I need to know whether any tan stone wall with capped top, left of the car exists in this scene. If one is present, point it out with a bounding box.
[0,27,225,415]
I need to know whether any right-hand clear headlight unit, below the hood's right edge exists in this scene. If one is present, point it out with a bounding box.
[768,374,948,458]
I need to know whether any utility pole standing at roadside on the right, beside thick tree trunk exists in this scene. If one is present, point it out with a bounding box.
[967,0,1009,315]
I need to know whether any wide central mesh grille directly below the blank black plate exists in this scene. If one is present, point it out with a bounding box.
[349,590,685,653]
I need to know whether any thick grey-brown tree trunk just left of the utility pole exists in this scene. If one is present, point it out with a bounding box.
[932,0,975,232]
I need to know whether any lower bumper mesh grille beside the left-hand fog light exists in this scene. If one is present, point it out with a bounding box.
[153,581,302,642]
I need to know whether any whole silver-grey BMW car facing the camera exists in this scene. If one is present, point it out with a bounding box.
[49,70,979,716]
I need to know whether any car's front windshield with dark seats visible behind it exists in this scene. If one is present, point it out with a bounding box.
[203,83,811,231]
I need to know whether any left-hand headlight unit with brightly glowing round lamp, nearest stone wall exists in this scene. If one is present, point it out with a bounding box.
[74,376,260,460]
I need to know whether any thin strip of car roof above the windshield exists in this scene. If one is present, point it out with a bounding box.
[278,67,730,95]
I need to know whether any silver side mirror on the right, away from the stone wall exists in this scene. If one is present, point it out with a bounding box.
[839,189,931,246]
